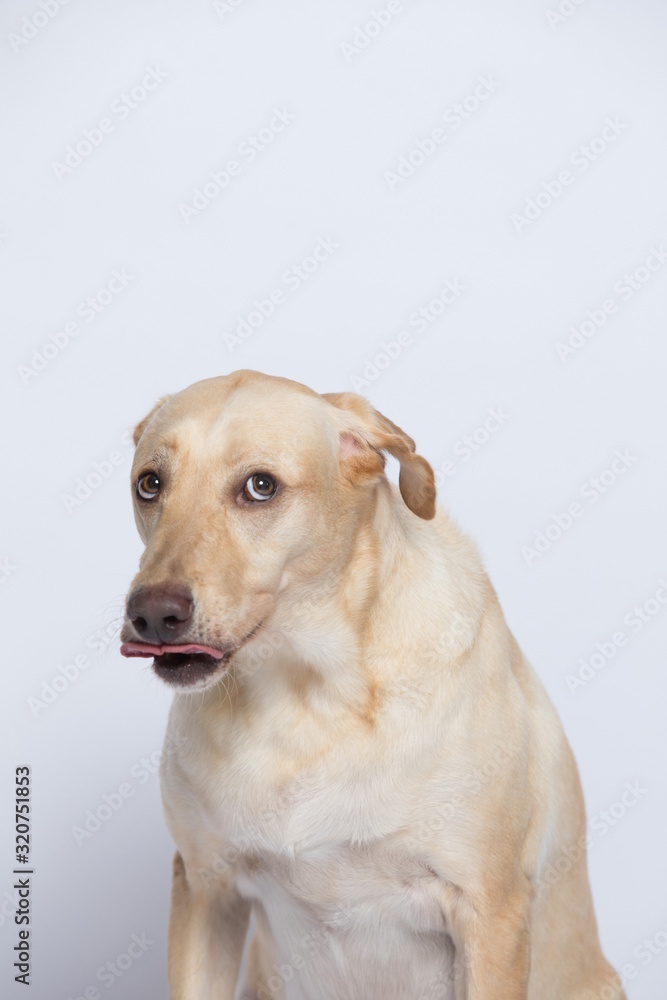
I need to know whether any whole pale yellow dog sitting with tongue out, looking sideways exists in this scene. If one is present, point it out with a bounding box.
[121,371,624,1000]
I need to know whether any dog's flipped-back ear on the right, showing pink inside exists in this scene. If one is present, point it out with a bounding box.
[323,392,435,521]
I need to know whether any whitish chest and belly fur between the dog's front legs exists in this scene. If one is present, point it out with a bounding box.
[165,696,460,1000]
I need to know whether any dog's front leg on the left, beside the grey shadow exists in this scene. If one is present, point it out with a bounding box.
[167,853,250,1000]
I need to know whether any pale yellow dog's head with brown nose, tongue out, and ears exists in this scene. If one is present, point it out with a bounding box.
[121,371,435,690]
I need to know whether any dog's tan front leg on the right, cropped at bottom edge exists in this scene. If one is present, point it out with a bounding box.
[448,891,530,1000]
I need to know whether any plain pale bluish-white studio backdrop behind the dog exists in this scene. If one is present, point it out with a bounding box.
[0,0,667,1000]
